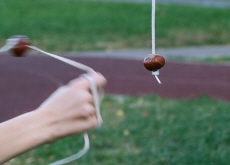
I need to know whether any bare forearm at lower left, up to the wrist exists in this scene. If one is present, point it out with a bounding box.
[0,111,50,164]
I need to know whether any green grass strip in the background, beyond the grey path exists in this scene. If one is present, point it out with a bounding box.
[0,0,230,52]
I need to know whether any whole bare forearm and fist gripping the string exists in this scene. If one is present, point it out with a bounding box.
[0,73,106,164]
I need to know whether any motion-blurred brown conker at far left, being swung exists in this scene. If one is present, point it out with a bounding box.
[10,35,30,57]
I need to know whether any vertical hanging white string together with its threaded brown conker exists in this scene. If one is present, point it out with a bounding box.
[143,0,165,84]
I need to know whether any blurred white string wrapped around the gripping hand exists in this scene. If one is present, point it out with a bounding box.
[0,39,102,165]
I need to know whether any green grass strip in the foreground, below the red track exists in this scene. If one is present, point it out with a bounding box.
[6,96,230,165]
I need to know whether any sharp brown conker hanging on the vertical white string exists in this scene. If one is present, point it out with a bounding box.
[143,54,165,71]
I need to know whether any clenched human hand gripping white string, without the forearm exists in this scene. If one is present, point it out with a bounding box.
[36,73,106,142]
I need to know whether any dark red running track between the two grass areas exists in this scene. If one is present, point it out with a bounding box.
[0,54,230,122]
